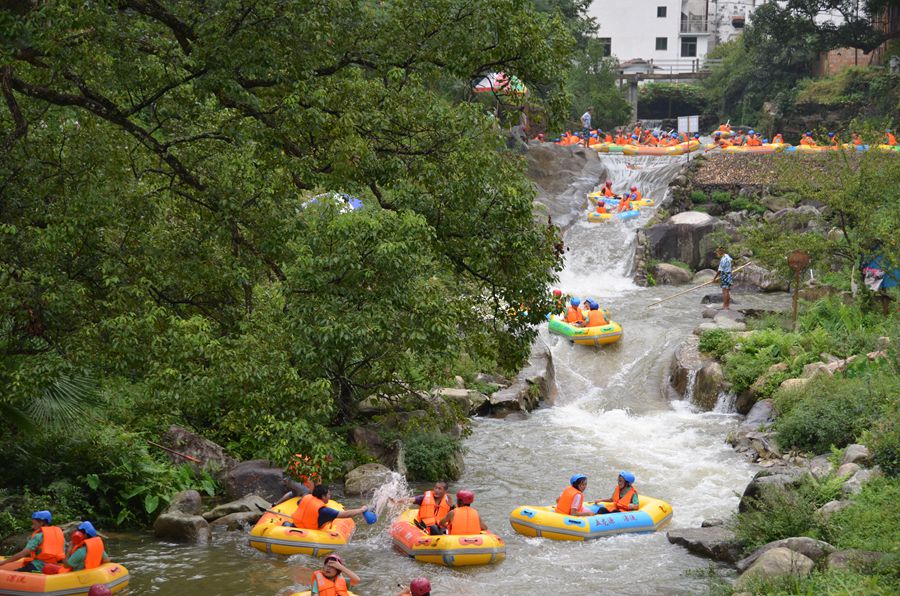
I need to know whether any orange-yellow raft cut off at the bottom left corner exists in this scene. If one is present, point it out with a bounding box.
[0,560,130,596]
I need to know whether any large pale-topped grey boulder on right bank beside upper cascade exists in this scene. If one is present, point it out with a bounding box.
[647,211,731,270]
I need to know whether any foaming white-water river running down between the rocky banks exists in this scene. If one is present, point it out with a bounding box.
[110,156,771,595]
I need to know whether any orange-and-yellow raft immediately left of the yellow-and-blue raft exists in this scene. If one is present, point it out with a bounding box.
[391,509,506,567]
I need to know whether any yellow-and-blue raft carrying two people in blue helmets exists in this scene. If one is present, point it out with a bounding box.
[509,495,672,541]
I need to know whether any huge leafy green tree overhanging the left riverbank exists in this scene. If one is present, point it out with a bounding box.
[0,0,572,484]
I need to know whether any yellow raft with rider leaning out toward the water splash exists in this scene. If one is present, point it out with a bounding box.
[249,498,356,557]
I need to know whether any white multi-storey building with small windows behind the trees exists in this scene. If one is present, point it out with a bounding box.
[589,0,766,73]
